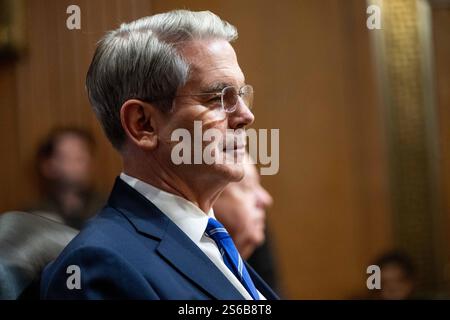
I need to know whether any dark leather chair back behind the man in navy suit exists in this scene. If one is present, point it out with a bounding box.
[0,211,78,300]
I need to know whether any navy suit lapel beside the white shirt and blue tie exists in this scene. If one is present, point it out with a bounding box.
[108,178,244,300]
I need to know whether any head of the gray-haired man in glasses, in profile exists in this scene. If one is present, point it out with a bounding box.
[86,10,254,209]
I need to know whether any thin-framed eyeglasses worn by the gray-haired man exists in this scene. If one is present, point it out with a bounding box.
[177,84,253,113]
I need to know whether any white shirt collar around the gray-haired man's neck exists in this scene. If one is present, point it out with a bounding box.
[120,172,215,243]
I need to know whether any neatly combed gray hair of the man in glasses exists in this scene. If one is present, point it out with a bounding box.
[86,10,237,150]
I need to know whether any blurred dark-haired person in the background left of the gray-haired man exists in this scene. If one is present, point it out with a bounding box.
[27,127,105,229]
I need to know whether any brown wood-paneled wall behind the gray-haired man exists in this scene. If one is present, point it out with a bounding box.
[0,0,391,298]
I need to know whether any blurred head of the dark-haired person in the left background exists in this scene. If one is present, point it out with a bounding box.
[37,128,94,190]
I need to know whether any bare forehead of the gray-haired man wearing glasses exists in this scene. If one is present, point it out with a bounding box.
[181,39,245,89]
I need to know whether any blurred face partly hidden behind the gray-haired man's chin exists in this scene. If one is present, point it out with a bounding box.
[214,161,273,259]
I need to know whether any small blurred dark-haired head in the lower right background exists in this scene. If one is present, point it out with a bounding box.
[376,252,415,300]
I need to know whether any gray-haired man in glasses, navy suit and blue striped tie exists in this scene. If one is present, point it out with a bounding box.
[41,10,277,300]
